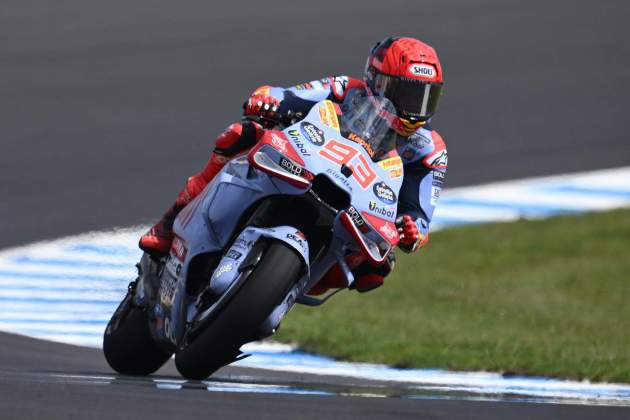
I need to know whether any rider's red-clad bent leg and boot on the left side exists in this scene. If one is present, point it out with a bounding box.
[139,122,264,257]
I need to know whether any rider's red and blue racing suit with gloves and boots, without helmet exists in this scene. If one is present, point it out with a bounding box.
[140,76,447,294]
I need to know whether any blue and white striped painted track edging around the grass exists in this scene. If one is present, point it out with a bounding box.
[0,167,630,406]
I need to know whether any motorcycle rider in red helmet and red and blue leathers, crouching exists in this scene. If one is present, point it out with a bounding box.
[139,37,447,294]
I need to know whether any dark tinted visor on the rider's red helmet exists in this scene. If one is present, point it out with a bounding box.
[375,74,442,120]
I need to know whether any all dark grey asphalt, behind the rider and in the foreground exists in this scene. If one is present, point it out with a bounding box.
[0,0,630,419]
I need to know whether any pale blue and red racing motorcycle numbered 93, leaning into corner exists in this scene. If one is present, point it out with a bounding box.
[103,91,403,379]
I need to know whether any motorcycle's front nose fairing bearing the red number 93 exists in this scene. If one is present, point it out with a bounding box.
[283,99,403,262]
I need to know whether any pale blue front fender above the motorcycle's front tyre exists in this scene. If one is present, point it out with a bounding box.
[210,226,310,295]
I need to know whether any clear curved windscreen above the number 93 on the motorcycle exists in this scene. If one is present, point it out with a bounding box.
[339,89,397,162]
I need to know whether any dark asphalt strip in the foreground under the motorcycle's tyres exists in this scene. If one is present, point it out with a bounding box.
[0,333,628,420]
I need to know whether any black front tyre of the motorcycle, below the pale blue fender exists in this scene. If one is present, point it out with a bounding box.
[175,241,303,380]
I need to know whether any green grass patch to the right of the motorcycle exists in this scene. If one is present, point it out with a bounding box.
[276,210,630,382]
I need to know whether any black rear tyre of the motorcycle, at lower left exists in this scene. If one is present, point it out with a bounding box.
[103,291,172,375]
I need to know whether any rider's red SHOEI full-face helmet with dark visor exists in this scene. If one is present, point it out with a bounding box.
[364,37,443,135]
